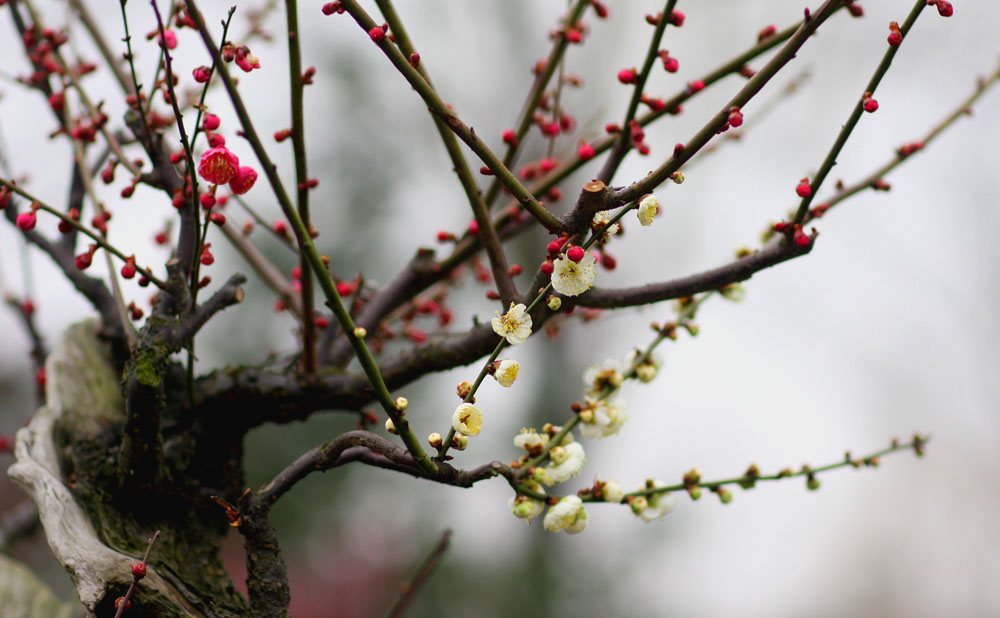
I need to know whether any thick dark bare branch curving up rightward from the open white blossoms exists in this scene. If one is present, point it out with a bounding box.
[564,238,815,309]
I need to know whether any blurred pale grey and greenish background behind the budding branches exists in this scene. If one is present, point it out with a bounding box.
[0,0,1000,617]
